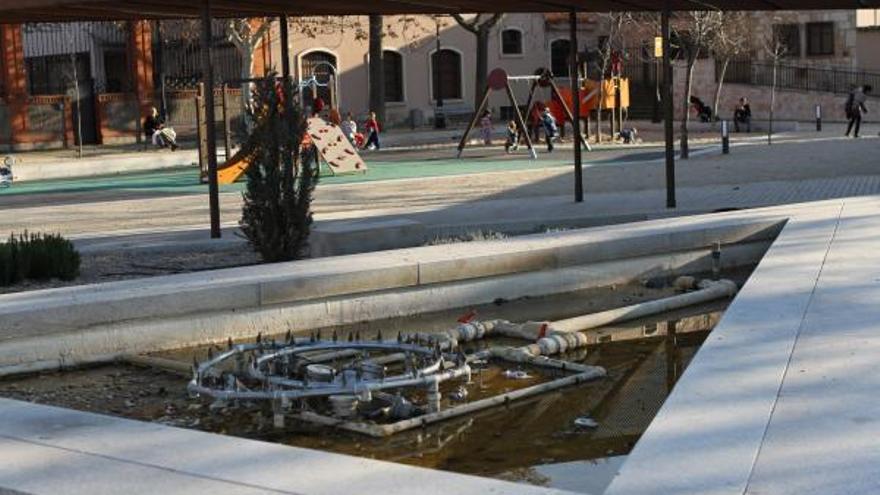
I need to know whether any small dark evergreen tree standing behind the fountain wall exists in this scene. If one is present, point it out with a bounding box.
[240,73,319,262]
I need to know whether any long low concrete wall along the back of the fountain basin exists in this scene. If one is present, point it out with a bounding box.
[0,215,783,371]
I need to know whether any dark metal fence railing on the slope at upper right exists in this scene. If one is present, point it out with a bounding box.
[715,60,880,94]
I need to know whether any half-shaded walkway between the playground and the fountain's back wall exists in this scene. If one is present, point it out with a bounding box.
[0,137,880,255]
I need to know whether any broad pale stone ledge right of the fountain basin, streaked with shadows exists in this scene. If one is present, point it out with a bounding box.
[606,197,880,495]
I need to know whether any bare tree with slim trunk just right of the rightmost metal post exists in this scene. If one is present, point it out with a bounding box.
[673,11,721,159]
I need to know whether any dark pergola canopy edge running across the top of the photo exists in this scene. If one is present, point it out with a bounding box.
[0,0,880,23]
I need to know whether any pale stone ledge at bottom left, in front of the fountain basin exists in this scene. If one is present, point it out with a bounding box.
[0,399,570,495]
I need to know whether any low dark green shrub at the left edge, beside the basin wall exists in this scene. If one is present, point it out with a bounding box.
[0,232,80,285]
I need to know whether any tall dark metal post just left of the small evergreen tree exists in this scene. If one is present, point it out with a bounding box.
[201,0,220,239]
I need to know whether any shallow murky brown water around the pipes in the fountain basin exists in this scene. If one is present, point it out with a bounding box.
[0,269,750,490]
